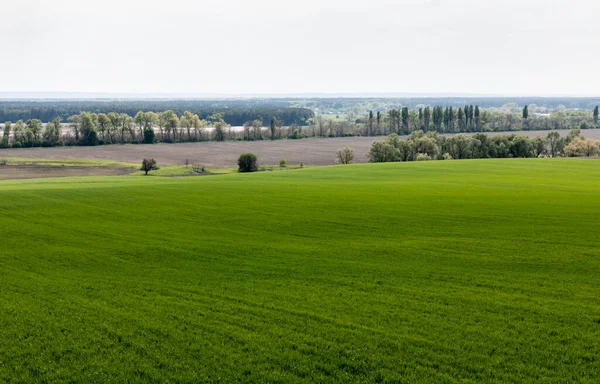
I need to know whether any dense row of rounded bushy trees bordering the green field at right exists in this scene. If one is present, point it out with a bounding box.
[368,129,600,163]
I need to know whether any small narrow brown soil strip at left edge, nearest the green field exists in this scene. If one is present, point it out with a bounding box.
[0,164,135,180]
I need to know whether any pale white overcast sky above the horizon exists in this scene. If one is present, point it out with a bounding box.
[0,0,600,95]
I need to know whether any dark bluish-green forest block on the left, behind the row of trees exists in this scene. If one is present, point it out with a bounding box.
[0,99,314,126]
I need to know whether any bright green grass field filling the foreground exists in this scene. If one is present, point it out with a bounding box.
[0,159,600,383]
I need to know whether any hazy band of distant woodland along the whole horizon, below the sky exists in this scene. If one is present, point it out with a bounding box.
[0,97,600,126]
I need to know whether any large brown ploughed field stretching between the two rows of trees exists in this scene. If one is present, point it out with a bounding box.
[0,129,600,168]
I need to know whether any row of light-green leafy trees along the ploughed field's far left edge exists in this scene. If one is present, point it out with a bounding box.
[0,110,284,148]
